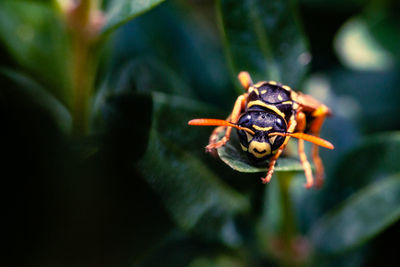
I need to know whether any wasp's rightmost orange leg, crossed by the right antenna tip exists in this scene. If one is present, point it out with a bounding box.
[310,105,331,188]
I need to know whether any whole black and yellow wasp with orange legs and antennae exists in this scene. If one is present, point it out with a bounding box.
[188,71,334,188]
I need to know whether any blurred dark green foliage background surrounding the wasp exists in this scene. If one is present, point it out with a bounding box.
[0,0,400,266]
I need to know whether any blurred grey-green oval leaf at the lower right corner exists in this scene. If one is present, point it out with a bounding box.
[311,174,400,253]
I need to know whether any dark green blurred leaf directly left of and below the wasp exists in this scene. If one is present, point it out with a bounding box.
[135,93,249,245]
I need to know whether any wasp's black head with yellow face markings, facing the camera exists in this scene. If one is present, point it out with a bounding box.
[237,111,287,161]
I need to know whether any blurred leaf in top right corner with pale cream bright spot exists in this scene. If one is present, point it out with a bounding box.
[335,1,400,71]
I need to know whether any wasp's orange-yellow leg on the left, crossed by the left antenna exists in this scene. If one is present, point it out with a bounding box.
[206,93,247,152]
